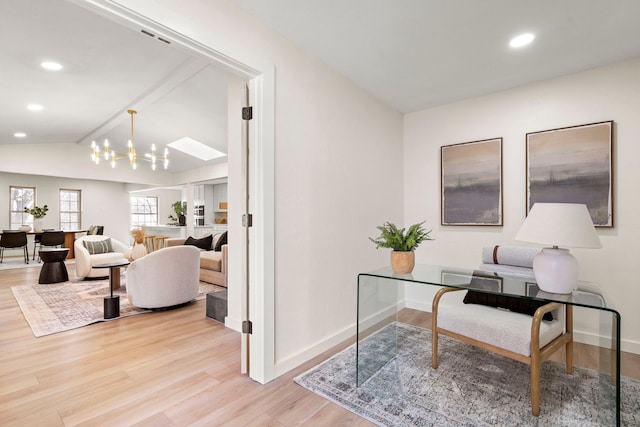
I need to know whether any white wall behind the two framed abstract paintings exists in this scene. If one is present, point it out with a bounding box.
[404,59,640,353]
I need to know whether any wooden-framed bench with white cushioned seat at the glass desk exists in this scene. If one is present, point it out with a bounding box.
[431,287,573,416]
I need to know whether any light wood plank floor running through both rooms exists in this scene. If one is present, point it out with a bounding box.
[0,268,640,426]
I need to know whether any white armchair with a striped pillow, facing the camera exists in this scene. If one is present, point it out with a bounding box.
[73,235,129,279]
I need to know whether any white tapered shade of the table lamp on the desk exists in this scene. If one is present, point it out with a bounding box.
[516,203,602,249]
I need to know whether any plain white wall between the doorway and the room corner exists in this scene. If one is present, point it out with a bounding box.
[105,0,403,374]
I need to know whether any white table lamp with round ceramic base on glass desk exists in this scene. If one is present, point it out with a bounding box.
[516,203,602,294]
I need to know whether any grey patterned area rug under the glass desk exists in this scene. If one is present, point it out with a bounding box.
[295,323,640,427]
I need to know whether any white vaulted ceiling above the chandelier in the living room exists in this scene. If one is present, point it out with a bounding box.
[0,0,227,172]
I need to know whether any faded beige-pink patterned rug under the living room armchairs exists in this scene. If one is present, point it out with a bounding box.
[11,276,224,337]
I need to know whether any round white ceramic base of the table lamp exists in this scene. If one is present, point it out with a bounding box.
[533,248,578,294]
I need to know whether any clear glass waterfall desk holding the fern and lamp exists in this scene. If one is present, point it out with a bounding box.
[356,265,620,425]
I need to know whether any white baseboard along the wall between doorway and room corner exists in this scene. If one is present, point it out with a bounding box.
[275,306,401,377]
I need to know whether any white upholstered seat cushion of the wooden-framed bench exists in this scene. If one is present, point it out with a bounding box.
[438,304,563,357]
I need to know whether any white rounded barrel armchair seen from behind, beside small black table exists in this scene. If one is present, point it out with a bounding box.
[127,246,200,309]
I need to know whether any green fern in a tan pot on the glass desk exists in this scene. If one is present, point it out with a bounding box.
[369,221,433,274]
